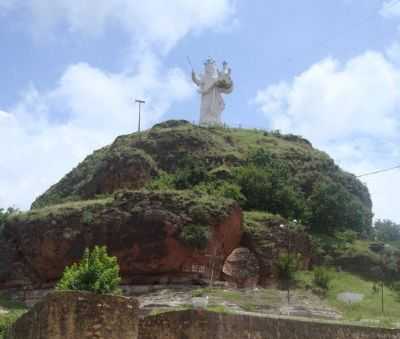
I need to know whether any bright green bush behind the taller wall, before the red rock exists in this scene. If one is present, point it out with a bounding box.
[56,246,121,294]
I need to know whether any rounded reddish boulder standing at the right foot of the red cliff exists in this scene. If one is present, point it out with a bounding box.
[222,247,260,288]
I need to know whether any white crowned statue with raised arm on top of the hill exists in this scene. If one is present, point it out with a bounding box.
[192,59,233,126]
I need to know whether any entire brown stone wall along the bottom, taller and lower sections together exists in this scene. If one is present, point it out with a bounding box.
[7,292,400,339]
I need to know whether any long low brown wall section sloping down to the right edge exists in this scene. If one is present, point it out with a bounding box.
[139,311,400,339]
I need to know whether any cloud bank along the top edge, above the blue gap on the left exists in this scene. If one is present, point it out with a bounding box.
[5,0,235,51]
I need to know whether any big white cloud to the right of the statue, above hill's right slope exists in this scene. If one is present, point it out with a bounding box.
[254,45,400,221]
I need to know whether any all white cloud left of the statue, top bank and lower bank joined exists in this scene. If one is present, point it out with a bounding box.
[0,0,235,208]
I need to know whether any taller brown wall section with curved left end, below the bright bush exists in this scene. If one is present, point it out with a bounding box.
[7,292,139,339]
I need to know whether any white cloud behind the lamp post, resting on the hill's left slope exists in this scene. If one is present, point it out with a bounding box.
[0,59,192,208]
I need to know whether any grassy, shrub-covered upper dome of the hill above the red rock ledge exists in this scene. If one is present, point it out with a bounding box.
[32,121,372,233]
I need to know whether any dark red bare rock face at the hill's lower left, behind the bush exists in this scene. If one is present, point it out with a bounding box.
[0,192,242,288]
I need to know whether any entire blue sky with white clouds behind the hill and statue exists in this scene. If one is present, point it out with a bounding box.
[0,0,400,222]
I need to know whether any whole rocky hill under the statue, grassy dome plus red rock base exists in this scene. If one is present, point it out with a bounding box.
[0,121,372,288]
